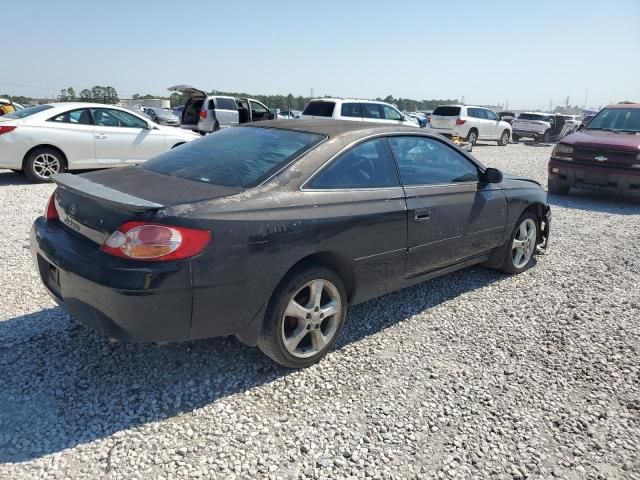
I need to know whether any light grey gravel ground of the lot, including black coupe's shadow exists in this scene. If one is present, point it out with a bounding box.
[0,144,640,479]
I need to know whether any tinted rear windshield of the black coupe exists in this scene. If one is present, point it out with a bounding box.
[140,127,326,188]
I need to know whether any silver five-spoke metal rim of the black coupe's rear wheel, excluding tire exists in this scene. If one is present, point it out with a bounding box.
[281,279,342,358]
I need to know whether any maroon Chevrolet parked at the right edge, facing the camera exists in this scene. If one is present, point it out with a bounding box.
[548,103,640,197]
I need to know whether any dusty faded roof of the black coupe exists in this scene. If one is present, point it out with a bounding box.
[241,119,425,138]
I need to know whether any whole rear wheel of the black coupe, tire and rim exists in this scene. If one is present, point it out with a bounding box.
[258,266,347,368]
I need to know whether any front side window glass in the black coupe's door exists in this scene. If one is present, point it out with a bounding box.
[389,136,478,186]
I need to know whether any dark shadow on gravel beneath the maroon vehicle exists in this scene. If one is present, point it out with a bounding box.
[547,189,640,215]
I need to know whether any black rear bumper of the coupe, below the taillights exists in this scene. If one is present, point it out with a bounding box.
[30,217,192,342]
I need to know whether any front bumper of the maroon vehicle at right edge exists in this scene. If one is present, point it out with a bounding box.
[548,158,640,197]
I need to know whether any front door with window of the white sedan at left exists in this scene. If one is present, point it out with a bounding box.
[91,108,166,166]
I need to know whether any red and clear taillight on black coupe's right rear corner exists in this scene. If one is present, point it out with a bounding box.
[100,222,212,262]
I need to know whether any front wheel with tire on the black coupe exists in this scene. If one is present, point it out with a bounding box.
[500,212,540,275]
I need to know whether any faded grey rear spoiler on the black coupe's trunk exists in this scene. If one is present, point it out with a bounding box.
[51,173,165,212]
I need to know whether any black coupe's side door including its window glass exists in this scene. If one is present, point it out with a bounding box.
[389,135,507,277]
